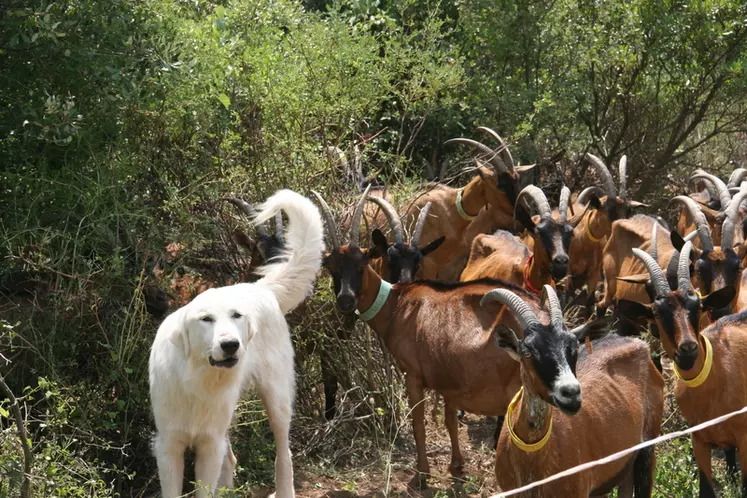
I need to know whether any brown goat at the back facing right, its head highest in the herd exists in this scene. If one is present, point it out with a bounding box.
[405,127,534,279]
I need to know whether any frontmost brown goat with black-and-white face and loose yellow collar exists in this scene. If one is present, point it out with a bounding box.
[483,285,664,498]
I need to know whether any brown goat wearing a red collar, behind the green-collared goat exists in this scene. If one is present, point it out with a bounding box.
[460,185,573,293]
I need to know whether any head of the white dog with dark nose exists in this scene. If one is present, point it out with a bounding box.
[167,286,254,368]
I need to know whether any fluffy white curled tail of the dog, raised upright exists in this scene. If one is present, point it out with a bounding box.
[254,190,324,314]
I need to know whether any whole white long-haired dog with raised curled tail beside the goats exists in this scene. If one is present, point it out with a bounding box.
[149,190,324,498]
